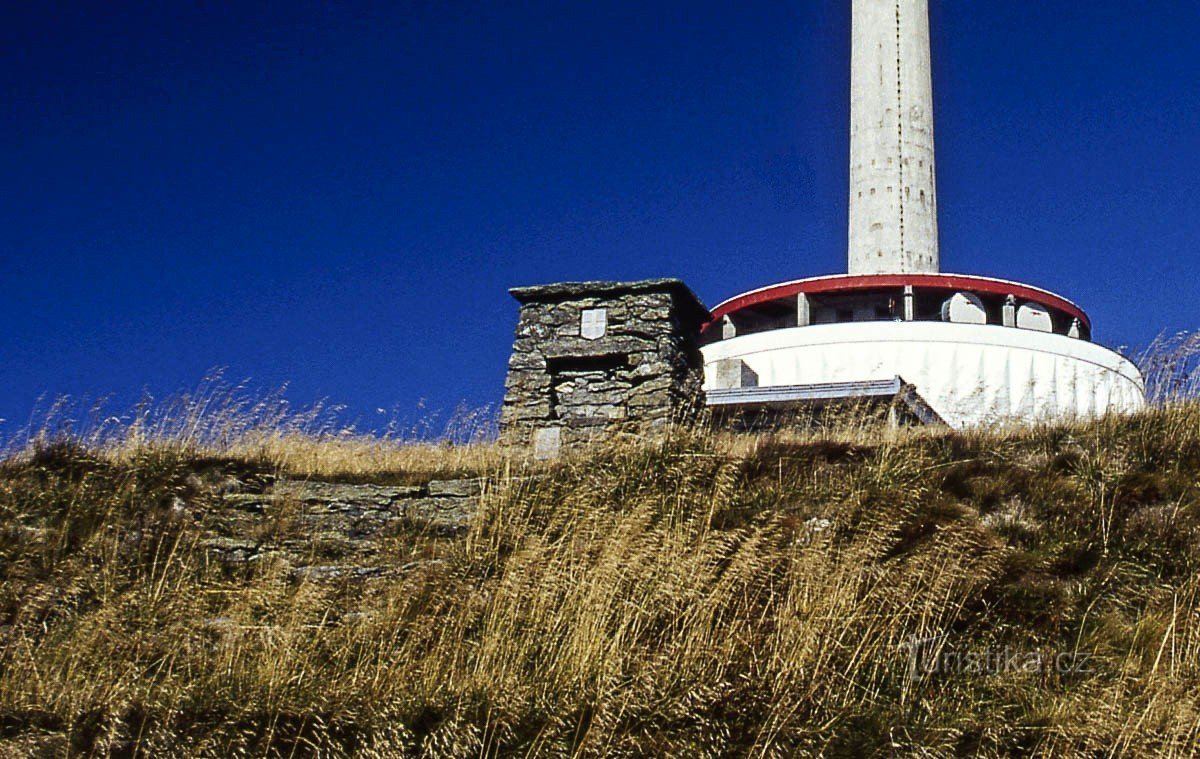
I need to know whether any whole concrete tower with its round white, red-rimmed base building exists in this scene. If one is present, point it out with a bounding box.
[701,0,1146,426]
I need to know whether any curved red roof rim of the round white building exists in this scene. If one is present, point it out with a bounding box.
[709,274,1092,330]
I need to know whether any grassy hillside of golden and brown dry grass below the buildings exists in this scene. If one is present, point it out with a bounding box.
[0,404,1200,757]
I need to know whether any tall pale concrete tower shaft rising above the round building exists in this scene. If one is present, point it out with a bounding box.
[850,0,940,275]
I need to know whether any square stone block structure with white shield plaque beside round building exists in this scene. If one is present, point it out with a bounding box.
[500,280,710,458]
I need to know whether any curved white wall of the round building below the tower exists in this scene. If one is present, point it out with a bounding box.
[703,322,1145,426]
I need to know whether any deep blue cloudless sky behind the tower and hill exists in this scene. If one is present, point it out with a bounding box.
[0,0,1200,429]
